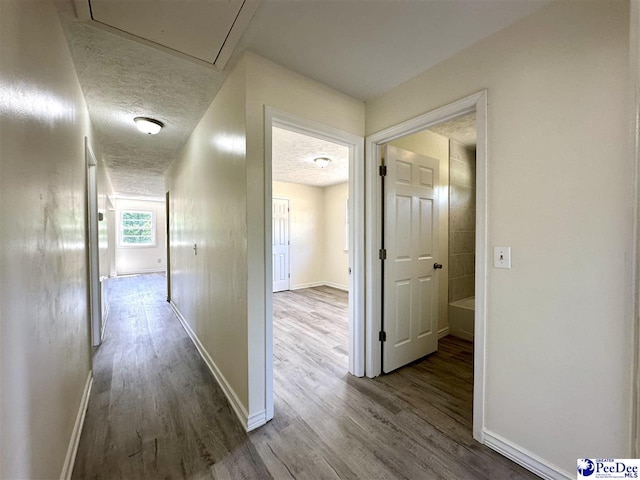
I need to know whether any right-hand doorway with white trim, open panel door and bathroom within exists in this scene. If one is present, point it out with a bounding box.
[366,92,487,443]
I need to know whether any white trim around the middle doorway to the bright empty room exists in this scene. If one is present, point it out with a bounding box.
[264,106,365,420]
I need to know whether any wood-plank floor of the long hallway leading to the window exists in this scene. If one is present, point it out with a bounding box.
[73,274,270,479]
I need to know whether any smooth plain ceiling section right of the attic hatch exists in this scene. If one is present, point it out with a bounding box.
[243,0,548,100]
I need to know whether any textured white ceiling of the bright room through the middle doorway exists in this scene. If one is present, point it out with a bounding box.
[272,127,349,187]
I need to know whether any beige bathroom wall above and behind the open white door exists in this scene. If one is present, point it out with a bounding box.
[389,130,449,332]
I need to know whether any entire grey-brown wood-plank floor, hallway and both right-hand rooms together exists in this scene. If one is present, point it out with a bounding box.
[73,275,537,480]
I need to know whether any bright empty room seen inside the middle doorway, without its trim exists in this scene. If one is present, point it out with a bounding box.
[271,127,350,403]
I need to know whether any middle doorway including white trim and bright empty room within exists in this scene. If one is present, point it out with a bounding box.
[265,108,365,420]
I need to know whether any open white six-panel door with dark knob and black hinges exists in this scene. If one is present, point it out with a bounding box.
[383,146,444,372]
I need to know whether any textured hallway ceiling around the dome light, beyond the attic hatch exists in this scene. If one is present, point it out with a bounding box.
[59,3,224,198]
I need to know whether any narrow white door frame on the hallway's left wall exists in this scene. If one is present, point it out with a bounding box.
[84,137,102,347]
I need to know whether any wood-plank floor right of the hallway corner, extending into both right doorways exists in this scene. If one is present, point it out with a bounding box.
[250,287,538,480]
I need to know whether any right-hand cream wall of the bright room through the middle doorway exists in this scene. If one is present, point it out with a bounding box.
[324,182,349,290]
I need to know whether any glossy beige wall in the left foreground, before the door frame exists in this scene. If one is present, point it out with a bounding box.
[0,0,91,478]
